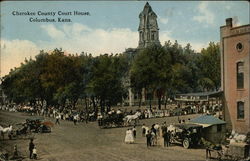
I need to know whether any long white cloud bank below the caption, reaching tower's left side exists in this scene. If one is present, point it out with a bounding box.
[39,23,138,56]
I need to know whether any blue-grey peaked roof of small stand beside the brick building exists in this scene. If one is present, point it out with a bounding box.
[189,115,226,127]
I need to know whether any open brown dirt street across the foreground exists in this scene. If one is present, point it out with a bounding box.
[0,111,205,161]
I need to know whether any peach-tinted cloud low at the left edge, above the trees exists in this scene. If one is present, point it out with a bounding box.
[0,39,39,76]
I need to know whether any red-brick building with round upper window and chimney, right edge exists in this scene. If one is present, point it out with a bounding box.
[220,18,250,133]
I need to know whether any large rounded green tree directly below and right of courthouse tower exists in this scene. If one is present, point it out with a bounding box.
[130,45,171,109]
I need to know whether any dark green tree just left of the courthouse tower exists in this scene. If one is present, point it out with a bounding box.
[88,54,126,112]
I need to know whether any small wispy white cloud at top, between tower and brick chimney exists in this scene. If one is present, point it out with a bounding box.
[193,1,215,25]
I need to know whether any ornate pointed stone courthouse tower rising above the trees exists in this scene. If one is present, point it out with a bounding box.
[138,2,160,48]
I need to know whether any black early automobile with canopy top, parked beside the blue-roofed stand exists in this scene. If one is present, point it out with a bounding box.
[168,124,202,149]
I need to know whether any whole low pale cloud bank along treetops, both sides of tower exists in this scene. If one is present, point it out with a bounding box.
[1,23,207,76]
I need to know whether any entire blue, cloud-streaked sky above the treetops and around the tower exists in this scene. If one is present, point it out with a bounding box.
[0,1,249,76]
